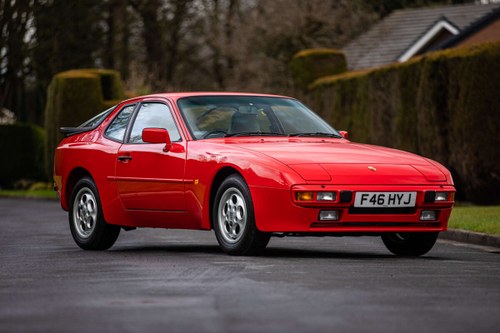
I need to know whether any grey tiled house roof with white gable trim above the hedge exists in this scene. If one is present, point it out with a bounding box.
[343,4,500,70]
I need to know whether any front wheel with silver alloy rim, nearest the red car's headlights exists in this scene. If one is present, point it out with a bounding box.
[212,174,271,255]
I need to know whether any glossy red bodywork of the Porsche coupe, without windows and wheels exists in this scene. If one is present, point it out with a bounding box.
[54,93,455,255]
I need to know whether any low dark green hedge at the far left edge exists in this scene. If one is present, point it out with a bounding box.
[0,123,46,187]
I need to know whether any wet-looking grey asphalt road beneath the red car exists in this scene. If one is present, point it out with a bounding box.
[0,199,500,333]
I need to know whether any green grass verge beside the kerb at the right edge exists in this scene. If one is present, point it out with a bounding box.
[448,205,500,235]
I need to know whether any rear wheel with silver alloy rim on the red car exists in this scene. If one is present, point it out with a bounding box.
[69,177,120,250]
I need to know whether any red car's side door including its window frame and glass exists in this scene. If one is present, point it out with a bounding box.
[115,102,186,211]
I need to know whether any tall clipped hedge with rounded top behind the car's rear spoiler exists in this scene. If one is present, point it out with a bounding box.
[45,69,125,176]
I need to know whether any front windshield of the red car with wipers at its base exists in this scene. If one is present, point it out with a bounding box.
[177,96,341,139]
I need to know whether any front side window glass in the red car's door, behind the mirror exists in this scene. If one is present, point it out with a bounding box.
[129,103,181,143]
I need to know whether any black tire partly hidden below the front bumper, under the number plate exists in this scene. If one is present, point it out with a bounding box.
[382,232,439,257]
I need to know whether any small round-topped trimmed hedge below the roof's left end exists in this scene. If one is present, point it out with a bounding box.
[290,49,347,89]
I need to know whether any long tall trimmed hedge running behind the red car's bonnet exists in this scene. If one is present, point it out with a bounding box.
[310,43,500,204]
